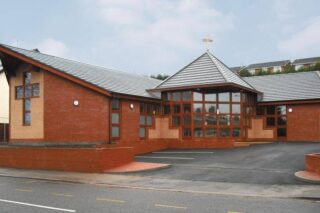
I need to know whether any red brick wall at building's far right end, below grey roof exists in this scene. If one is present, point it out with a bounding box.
[287,104,320,141]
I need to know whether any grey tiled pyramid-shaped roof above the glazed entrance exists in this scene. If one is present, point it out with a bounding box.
[154,51,255,91]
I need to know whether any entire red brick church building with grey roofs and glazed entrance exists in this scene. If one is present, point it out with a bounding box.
[0,44,320,154]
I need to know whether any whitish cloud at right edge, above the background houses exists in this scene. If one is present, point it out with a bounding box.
[278,16,320,55]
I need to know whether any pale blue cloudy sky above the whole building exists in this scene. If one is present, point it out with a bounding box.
[0,0,320,76]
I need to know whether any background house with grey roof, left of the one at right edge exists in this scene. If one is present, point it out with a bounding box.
[245,60,290,75]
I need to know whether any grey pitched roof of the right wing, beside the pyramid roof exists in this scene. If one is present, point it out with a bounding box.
[244,71,320,102]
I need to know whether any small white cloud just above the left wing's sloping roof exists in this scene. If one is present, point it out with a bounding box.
[35,38,68,57]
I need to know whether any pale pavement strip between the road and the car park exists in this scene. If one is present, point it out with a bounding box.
[0,168,320,199]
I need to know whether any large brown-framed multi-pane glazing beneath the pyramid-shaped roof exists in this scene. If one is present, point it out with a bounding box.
[162,91,244,138]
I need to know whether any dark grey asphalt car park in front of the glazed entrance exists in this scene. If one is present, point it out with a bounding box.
[130,142,320,184]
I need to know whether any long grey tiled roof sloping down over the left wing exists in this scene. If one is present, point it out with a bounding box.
[0,44,161,98]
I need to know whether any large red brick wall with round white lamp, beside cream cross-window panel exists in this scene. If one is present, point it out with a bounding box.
[44,72,109,142]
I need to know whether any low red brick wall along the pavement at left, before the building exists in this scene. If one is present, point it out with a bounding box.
[0,147,133,173]
